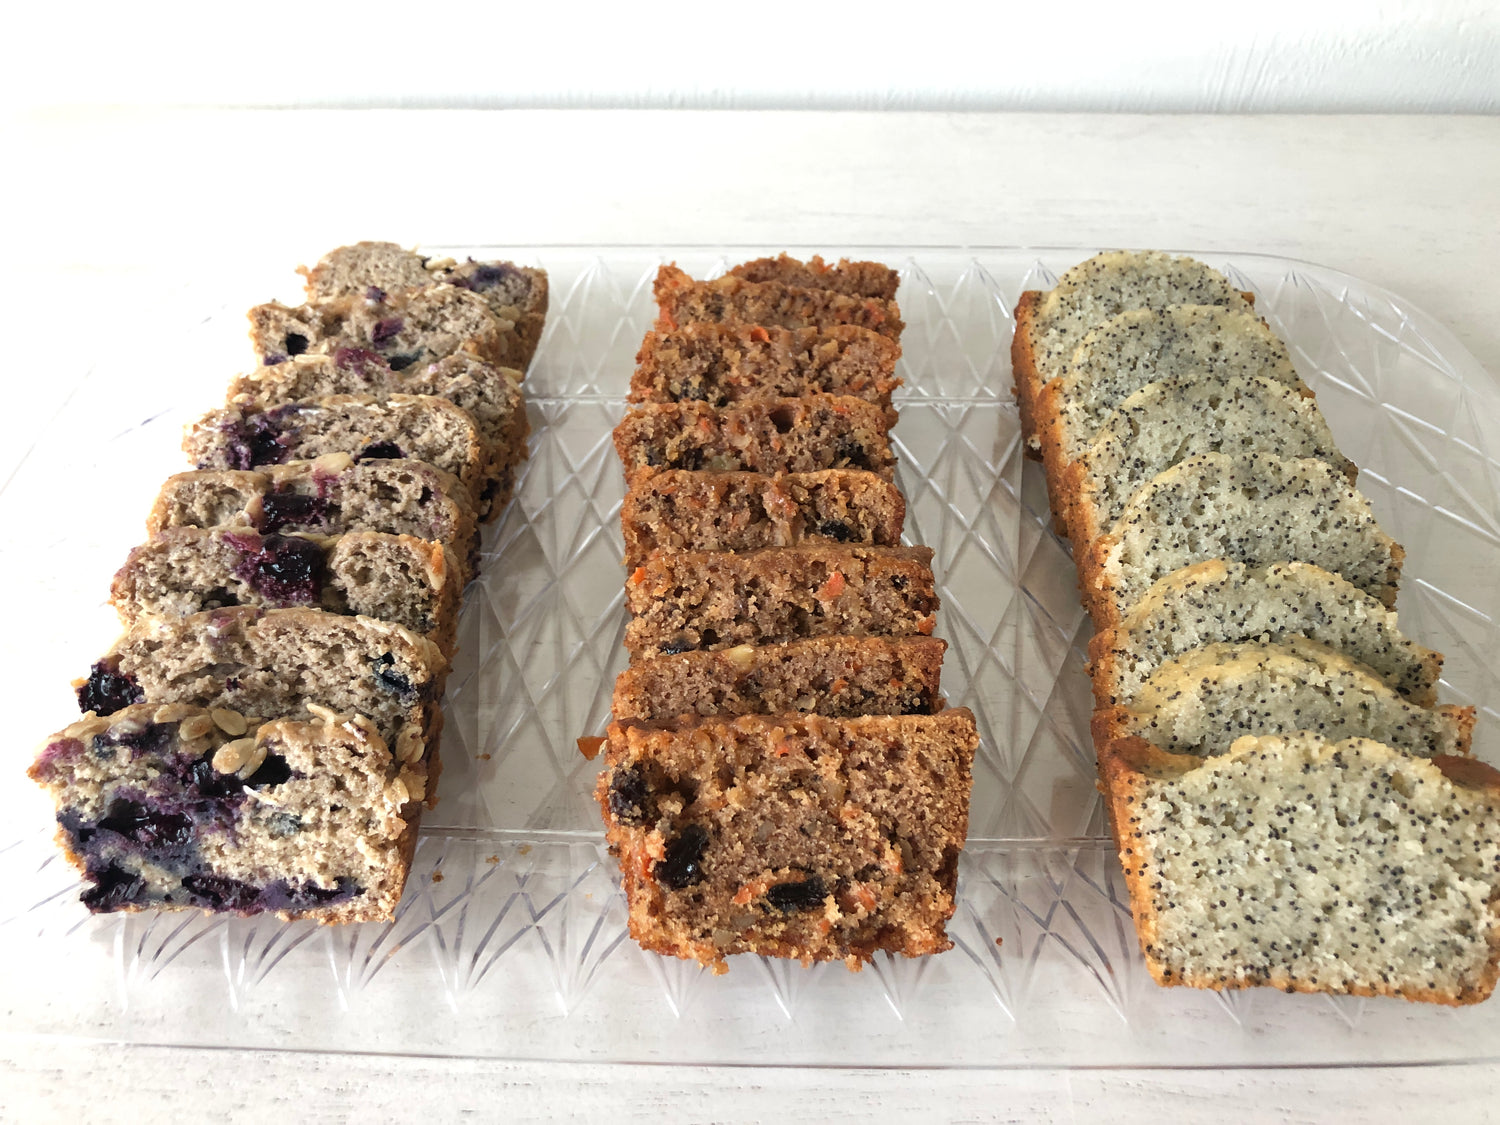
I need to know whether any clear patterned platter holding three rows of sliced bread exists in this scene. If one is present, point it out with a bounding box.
[0,246,1500,1068]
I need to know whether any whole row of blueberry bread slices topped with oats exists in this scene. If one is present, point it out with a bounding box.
[30,243,548,921]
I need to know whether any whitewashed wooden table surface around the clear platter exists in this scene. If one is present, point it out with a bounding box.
[0,110,1500,1121]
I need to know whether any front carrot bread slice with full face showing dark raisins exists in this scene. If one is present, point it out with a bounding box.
[597,710,978,972]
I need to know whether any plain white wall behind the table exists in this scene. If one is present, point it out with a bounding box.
[11,0,1500,113]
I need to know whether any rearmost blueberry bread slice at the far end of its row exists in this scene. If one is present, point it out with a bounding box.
[299,242,548,369]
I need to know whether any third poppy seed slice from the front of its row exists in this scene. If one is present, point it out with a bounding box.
[1089,558,1443,707]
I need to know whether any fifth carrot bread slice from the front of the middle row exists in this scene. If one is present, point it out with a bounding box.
[615,395,896,486]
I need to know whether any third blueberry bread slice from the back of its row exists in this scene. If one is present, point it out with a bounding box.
[228,348,531,516]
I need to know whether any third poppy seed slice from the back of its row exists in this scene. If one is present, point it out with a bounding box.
[1061,375,1356,549]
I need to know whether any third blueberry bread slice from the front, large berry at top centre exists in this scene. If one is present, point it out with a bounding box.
[111,528,462,653]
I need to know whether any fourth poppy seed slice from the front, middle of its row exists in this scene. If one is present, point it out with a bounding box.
[1077,453,1404,629]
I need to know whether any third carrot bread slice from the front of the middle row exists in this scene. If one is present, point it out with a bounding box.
[626,545,938,660]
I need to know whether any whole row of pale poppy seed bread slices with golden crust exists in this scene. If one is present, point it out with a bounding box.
[1013,254,1500,1004]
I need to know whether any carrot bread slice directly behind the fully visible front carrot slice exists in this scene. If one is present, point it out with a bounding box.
[614,636,948,720]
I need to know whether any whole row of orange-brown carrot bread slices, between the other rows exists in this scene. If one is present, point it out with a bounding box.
[597,255,978,972]
